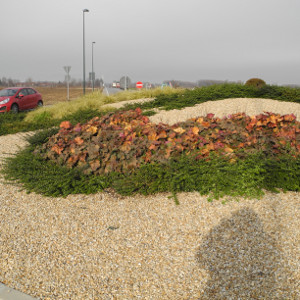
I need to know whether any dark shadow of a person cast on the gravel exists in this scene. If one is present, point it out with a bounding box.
[197,208,288,299]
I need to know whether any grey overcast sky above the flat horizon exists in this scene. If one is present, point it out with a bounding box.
[0,0,300,84]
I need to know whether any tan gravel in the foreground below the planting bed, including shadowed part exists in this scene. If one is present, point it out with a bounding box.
[0,100,300,299]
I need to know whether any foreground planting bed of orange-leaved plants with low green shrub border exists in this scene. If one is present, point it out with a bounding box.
[3,109,300,200]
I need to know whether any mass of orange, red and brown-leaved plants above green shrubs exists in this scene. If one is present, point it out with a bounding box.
[35,108,300,174]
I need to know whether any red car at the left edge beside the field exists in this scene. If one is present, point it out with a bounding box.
[0,87,43,113]
